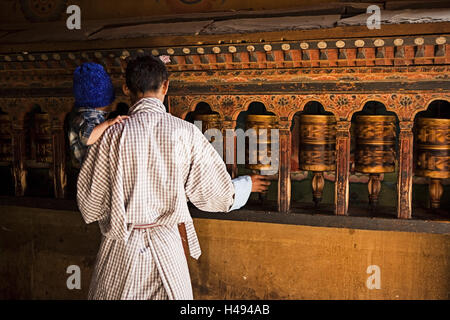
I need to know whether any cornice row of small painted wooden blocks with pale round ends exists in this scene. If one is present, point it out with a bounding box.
[0,34,449,71]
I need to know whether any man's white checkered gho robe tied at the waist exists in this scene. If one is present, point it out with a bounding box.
[77,98,234,299]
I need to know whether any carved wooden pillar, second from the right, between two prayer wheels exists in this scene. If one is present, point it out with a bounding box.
[334,121,351,215]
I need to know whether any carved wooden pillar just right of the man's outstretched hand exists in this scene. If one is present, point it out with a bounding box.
[278,120,291,212]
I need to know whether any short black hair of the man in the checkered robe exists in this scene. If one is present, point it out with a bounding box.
[126,55,169,95]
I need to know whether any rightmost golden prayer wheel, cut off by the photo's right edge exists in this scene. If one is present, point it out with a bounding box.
[415,118,450,209]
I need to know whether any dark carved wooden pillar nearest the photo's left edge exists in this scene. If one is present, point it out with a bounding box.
[12,114,27,197]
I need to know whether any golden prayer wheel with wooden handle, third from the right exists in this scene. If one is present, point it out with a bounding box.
[299,114,336,206]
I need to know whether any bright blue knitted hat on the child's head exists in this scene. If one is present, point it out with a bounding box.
[73,62,115,108]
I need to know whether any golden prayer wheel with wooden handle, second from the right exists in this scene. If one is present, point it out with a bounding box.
[355,115,397,207]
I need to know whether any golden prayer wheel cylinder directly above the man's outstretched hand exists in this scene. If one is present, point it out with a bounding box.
[245,115,279,172]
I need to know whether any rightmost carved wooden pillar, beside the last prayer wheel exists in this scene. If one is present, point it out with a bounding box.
[397,121,414,219]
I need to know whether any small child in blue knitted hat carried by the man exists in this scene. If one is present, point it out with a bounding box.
[69,62,127,164]
